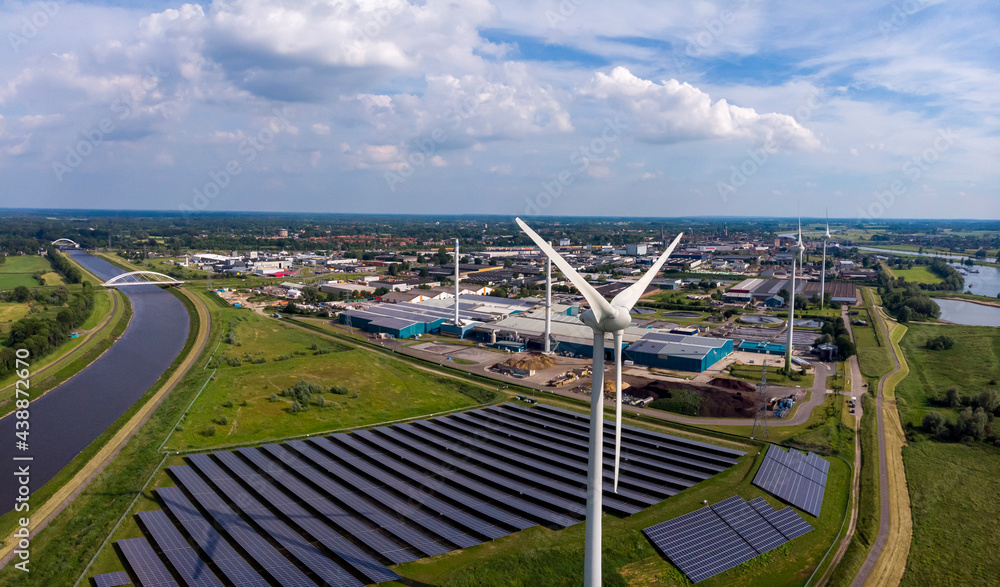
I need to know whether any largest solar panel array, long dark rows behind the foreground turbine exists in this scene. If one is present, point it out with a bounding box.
[95,404,748,587]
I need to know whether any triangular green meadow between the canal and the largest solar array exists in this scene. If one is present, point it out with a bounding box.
[168,308,496,450]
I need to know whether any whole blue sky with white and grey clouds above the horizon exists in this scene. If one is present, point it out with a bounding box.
[0,0,1000,219]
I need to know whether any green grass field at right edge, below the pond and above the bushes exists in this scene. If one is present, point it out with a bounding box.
[896,324,1000,426]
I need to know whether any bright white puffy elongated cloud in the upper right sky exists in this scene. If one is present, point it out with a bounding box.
[580,67,820,150]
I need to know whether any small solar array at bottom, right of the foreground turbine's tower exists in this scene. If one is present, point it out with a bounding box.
[643,496,812,583]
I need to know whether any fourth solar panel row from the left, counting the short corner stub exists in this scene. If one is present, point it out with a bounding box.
[156,487,268,587]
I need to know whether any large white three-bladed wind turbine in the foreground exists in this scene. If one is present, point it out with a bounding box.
[514,218,683,587]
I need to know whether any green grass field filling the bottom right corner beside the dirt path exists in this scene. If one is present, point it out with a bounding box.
[902,441,1000,587]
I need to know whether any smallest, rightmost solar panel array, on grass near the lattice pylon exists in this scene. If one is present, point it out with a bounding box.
[753,445,830,516]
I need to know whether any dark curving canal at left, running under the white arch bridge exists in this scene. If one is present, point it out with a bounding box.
[0,251,190,513]
